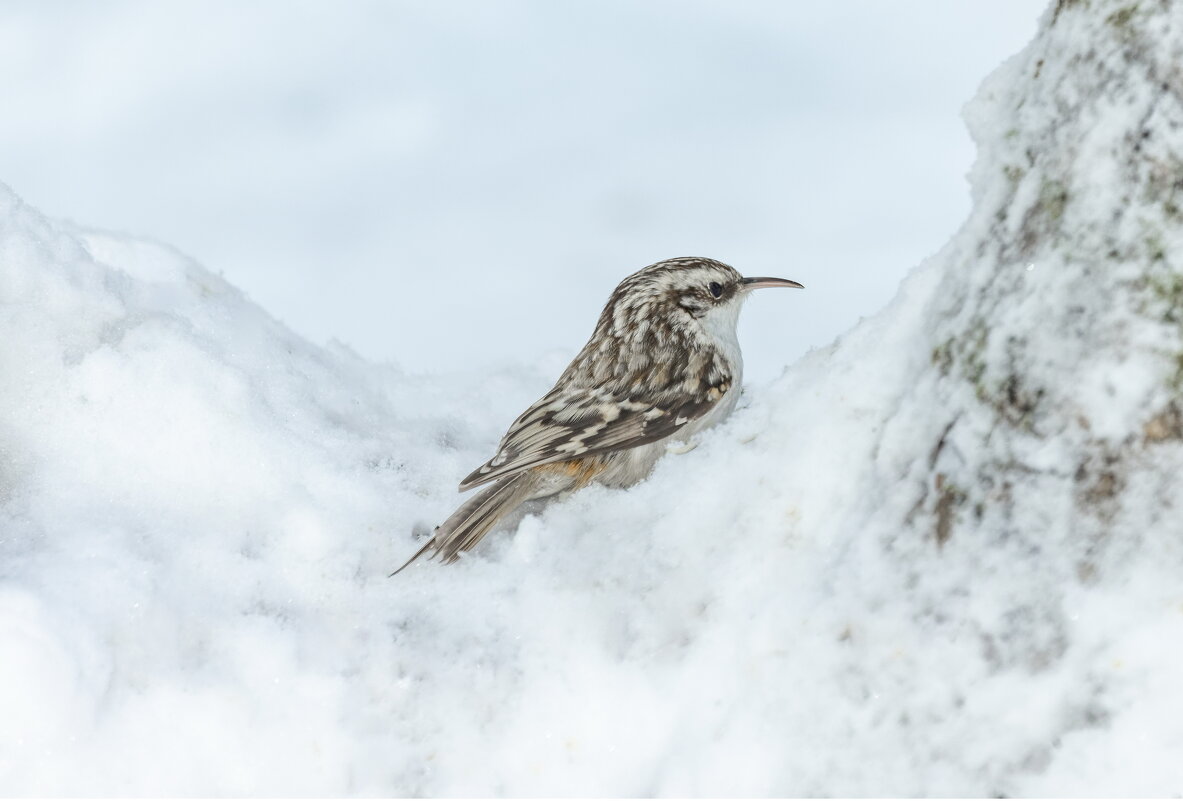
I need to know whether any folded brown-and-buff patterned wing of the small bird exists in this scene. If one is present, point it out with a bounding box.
[460,379,730,492]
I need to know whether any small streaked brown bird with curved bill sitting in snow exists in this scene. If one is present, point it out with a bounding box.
[390,257,804,576]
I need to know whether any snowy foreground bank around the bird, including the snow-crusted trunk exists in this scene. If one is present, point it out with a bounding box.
[0,0,1183,795]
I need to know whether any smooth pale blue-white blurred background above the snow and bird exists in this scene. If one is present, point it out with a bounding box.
[0,0,1045,380]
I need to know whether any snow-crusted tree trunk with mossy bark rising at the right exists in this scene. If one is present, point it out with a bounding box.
[780,0,1183,794]
